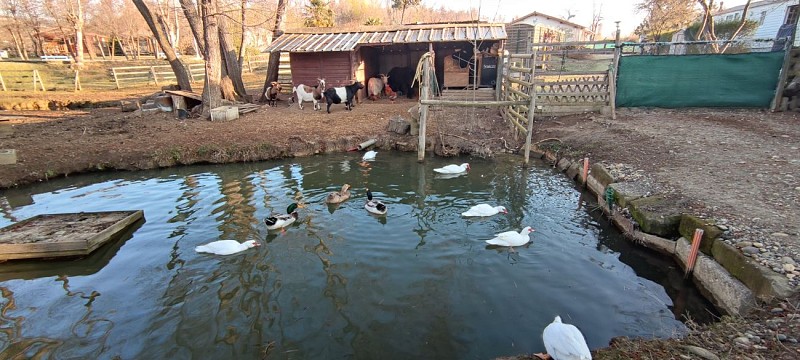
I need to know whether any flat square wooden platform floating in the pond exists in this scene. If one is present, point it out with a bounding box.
[0,210,144,261]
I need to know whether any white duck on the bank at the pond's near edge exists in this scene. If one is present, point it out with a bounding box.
[540,316,592,360]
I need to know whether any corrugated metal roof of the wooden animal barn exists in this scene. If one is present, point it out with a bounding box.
[265,23,506,52]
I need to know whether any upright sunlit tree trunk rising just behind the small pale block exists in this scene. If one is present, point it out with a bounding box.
[200,0,222,118]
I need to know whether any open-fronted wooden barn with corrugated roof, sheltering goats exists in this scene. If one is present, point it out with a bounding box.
[266,22,506,98]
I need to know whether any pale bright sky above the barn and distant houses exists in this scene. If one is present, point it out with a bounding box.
[423,0,746,37]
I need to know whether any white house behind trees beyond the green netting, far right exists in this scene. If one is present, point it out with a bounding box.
[714,0,800,40]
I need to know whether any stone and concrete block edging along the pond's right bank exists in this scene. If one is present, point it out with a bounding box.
[531,149,792,315]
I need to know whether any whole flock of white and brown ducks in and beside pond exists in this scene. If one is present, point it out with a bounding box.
[195,150,592,360]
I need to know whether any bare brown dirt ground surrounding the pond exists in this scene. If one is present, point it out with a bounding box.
[0,90,800,359]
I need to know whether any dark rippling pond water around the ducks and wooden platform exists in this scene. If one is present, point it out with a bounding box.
[0,152,711,359]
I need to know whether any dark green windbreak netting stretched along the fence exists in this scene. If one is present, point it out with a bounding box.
[616,51,783,108]
